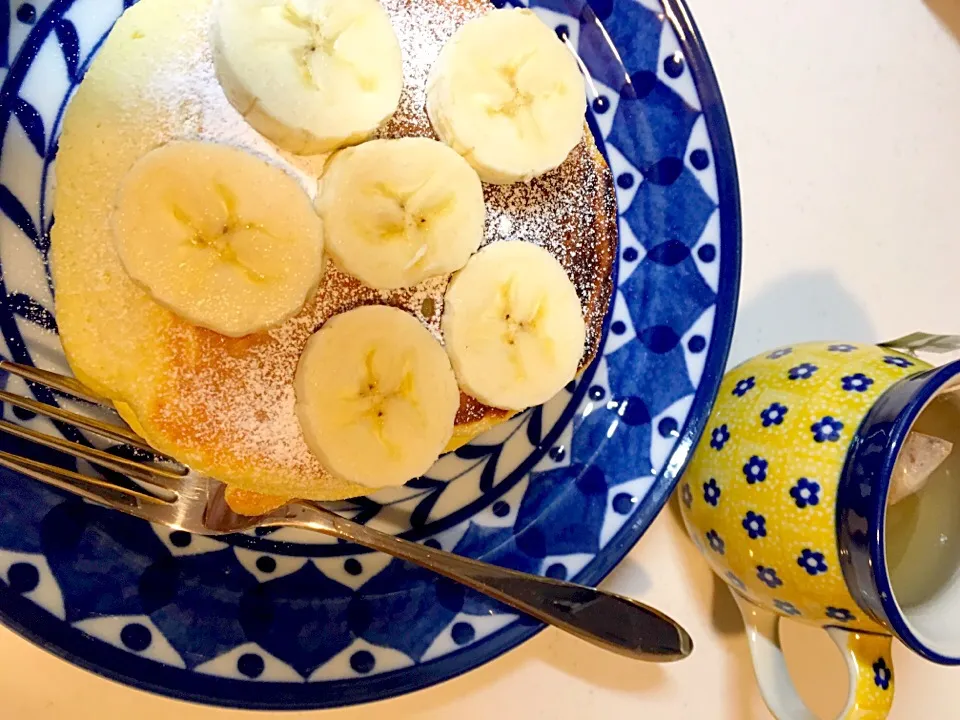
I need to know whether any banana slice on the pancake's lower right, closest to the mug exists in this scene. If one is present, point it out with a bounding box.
[442,241,586,410]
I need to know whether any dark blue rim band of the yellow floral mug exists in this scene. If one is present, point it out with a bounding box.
[837,360,960,665]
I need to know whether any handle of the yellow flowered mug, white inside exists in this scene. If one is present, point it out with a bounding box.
[734,593,893,720]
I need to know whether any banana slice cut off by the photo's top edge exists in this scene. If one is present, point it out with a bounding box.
[213,0,403,155]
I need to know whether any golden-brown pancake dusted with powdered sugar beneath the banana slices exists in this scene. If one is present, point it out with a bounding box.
[51,0,617,500]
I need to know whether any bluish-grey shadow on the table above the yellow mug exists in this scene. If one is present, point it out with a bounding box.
[729,272,876,367]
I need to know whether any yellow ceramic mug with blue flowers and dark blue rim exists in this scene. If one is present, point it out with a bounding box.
[679,336,960,720]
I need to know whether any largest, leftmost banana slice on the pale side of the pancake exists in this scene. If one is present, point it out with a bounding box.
[111,142,323,337]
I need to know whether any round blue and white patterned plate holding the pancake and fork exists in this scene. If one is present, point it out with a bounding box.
[0,0,740,709]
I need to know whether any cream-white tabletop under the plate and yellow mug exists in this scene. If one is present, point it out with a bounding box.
[0,0,960,720]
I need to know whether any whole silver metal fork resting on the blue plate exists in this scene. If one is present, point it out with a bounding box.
[0,361,693,662]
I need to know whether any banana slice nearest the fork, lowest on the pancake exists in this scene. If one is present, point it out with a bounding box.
[294,305,460,487]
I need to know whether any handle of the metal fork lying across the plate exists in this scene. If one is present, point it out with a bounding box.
[278,501,693,662]
